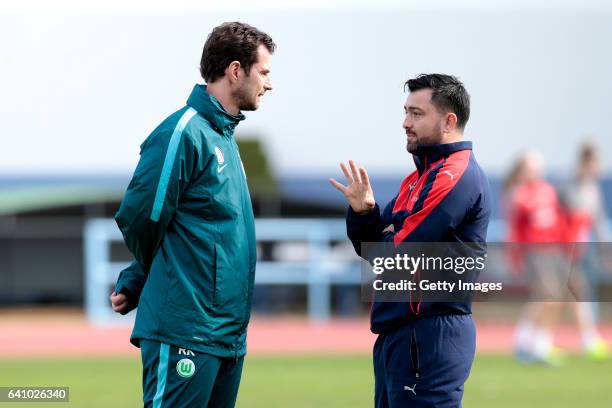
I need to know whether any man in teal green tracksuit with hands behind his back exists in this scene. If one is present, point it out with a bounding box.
[111,22,275,407]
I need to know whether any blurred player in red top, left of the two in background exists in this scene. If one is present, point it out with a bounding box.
[502,152,567,365]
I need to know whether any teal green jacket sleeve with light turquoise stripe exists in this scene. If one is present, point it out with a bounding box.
[115,115,199,274]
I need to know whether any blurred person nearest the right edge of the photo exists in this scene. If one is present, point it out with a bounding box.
[560,142,610,360]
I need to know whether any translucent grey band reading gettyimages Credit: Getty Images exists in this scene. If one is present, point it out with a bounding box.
[361,242,612,302]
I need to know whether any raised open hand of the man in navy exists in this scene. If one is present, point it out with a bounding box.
[329,160,376,214]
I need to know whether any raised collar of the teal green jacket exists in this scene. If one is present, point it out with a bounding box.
[187,85,245,136]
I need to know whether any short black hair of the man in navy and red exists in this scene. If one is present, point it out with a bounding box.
[404,74,470,129]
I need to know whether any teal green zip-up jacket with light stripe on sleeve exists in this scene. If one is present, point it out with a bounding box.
[115,85,256,357]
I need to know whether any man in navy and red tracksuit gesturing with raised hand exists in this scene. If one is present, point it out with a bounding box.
[330,74,491,408]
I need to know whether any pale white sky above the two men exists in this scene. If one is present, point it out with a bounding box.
[0,0,612,175]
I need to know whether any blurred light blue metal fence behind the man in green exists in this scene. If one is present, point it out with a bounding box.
[84,219,361,325]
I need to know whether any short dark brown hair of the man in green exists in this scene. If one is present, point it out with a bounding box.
[200,21,276,83]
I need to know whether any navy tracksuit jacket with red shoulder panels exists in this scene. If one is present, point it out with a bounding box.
[346,141,491,334]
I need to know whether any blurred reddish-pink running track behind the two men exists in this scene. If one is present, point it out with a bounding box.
[0,311,612,358]
